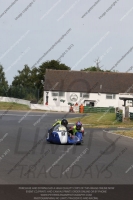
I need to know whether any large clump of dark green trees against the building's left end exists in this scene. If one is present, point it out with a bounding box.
[12,60,70,100]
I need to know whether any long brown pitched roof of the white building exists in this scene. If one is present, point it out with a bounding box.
[44,69,133,94]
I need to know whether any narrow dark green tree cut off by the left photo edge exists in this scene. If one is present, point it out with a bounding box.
[0,65,8,96]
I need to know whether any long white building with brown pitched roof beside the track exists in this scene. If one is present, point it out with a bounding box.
[44,70,133,111]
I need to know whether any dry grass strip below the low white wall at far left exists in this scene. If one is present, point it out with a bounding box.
[0,102,30,110]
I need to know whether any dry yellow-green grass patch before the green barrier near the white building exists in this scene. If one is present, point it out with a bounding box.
[68,113,133,128]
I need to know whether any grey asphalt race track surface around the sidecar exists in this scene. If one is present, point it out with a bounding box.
[0,111,133,184]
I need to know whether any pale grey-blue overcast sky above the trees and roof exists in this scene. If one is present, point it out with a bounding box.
[0,0,133,85]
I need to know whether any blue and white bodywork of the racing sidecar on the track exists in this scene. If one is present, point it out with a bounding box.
[47,124,83,144]
